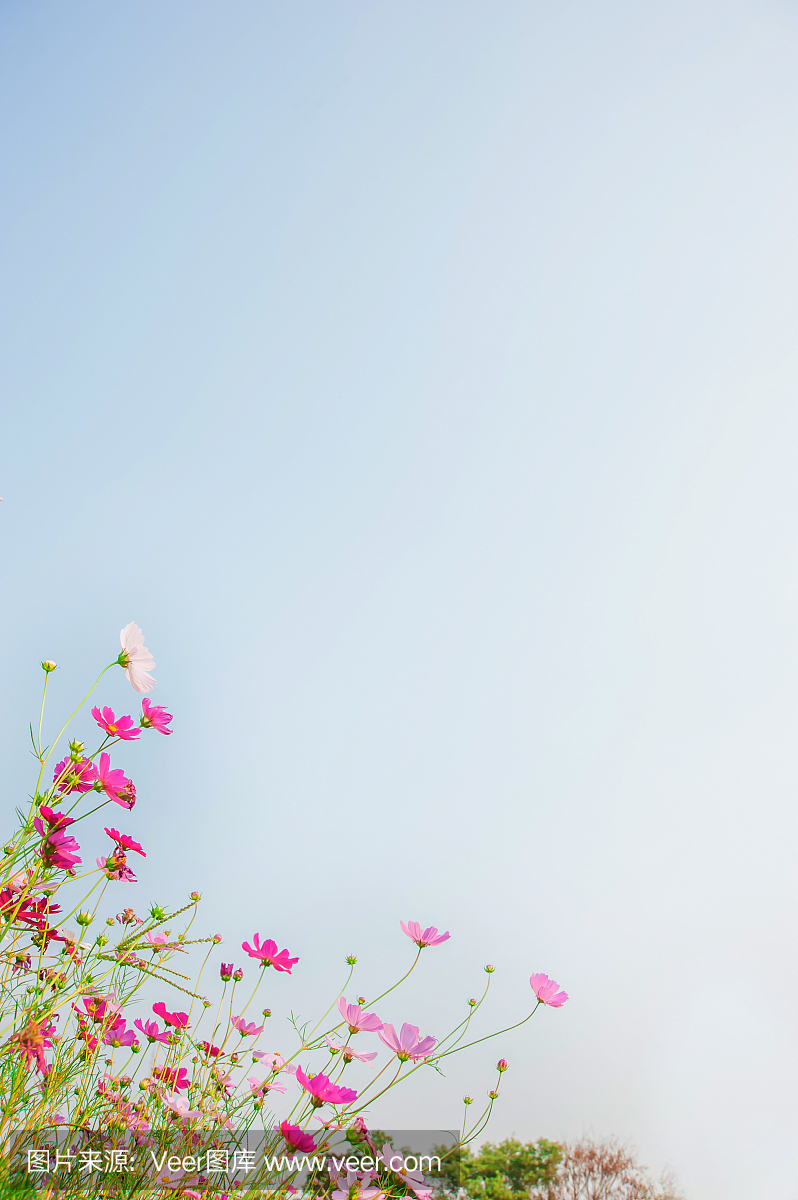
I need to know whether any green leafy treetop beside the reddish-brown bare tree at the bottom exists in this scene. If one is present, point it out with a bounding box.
[430,1138,563,1200]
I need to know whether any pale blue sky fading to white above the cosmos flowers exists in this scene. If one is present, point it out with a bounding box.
[0,0,798,1200]
